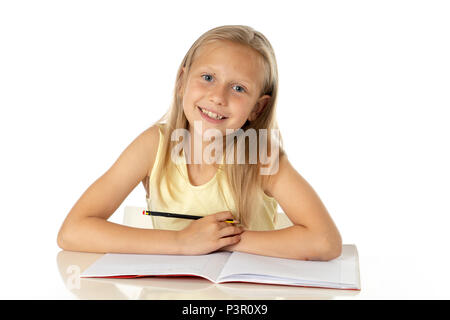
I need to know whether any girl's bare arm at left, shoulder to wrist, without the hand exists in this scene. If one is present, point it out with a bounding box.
[57,126,183,253]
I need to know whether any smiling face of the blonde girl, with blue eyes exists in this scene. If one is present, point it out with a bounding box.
[183,41,270,135]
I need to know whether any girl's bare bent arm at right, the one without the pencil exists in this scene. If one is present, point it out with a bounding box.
[225,157,342,260]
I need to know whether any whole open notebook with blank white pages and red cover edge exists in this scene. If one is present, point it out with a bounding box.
[81,245,360,290]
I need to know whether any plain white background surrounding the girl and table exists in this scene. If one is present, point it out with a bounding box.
[0,0,450,299]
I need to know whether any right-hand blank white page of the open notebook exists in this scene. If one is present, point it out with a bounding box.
[219,245,359,287]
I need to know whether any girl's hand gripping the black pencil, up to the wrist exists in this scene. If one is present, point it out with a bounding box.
[177,211,244,255]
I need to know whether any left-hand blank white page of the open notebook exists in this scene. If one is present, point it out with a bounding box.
[81,252,230,282]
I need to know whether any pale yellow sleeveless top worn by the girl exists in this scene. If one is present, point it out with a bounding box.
[146,126,278,231]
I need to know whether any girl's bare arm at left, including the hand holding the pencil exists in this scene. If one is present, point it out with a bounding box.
[57,126,242,254]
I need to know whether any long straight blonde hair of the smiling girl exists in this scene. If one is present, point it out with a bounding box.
[150,25,285,227]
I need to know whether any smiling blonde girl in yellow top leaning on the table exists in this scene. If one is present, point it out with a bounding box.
[57,26,342,260]
